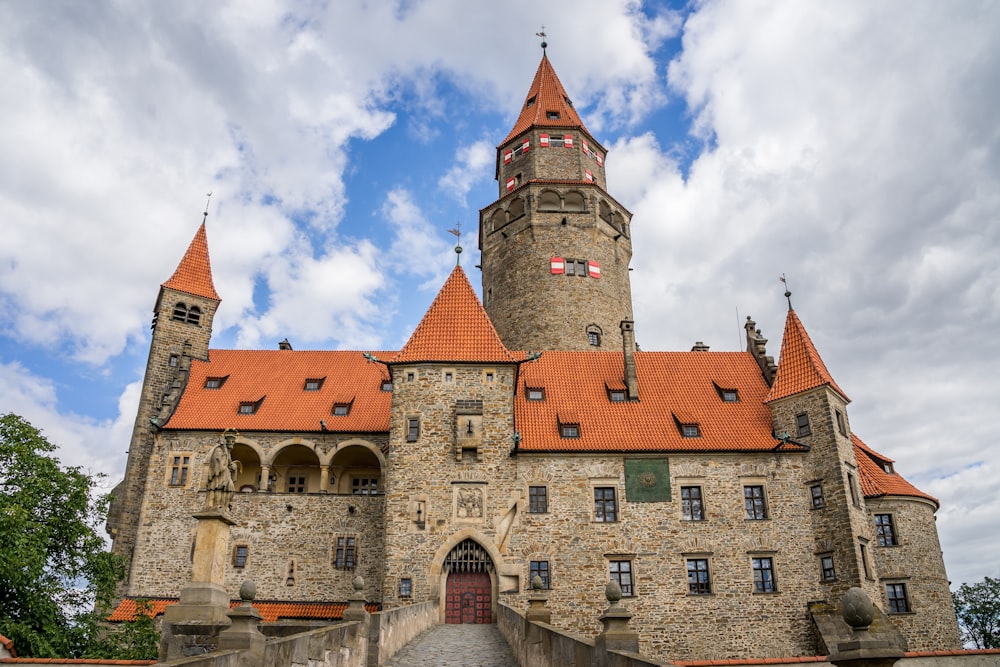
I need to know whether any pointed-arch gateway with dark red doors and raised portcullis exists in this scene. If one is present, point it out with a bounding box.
[442,538,496,623]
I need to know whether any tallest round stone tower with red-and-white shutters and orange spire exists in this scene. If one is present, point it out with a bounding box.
[479,49,632,350]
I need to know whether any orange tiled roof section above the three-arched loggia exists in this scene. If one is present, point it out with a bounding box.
[164,350,392,433]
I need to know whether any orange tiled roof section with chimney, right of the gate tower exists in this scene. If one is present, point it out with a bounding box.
[514,351,804,452]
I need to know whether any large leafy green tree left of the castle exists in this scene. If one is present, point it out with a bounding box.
[0,414,155,657]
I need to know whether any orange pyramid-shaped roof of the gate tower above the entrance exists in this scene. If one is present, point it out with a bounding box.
[389,266,515,364]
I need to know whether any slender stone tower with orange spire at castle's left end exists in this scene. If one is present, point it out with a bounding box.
[107,220,221,584]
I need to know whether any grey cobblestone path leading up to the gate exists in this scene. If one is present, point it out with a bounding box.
[386,624,517,667]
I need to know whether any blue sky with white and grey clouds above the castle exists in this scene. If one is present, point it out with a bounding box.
[0,0,1000,584]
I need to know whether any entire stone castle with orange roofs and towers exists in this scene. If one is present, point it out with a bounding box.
[108,49,960,659]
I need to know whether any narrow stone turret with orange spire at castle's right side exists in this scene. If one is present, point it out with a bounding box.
[767,302,880,600]
